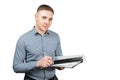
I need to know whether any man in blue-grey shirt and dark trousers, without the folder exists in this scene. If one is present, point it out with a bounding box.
[13,4,63,80]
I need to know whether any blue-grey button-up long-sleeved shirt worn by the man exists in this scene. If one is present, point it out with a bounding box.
[13,28,62,80]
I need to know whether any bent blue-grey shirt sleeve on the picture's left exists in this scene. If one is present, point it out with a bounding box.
[13,39,36,73]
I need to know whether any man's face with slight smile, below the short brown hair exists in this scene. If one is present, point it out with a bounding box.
[35,10,53,32]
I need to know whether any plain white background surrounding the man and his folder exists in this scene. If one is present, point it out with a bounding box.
[0,0,120,80]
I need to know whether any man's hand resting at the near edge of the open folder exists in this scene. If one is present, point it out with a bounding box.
[36,56,53,68]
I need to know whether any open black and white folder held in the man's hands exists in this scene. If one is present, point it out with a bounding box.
[51,55,84,68]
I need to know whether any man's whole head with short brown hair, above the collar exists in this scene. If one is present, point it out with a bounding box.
[35,5,54,34]
